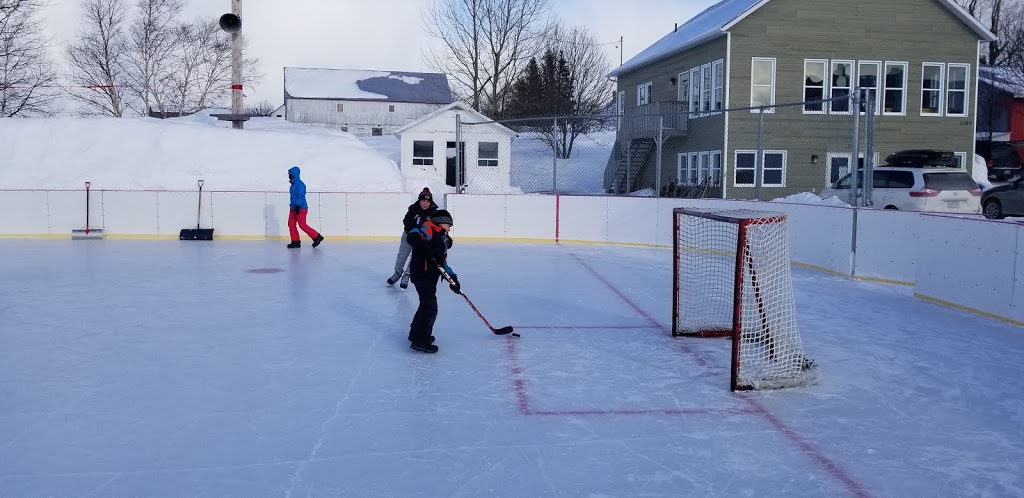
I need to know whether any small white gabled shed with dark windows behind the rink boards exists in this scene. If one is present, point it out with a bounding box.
[394,101,518,193]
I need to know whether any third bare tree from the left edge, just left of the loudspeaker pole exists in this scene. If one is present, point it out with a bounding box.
[124,0,182,115]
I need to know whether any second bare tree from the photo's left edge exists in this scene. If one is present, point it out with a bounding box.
[65,0,128,118]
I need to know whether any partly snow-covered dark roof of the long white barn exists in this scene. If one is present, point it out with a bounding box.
[285,68,454,103]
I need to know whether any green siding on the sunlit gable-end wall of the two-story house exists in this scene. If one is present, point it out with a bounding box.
[724,0,979,199]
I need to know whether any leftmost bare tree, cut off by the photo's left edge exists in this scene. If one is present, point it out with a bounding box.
[0,0,58,117]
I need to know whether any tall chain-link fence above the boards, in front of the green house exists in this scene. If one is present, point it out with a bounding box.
[457,94,878,202]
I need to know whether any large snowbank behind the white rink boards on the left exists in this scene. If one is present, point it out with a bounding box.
[0,112,407,192]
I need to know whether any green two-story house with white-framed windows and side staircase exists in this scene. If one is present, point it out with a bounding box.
[605,0,995,199]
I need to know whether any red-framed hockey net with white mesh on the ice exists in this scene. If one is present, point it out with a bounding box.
[672,208,820,390]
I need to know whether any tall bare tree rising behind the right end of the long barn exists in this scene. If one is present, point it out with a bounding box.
[425,0,549,116]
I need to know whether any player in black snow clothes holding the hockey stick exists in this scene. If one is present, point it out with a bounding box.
[406,209,462,352]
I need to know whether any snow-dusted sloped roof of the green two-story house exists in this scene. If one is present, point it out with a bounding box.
[608,0,995,77]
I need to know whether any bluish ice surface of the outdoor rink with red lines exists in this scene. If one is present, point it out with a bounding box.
[0,239,1024,497]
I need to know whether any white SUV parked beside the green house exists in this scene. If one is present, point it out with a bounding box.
[820,166,981,214]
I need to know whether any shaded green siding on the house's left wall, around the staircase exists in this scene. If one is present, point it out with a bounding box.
[616,36,728,195]
